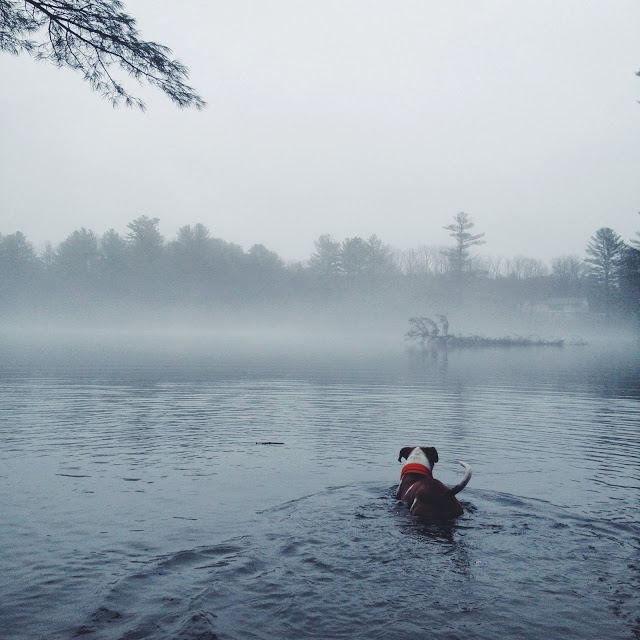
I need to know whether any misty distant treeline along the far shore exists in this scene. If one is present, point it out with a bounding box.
[0,213,640,324]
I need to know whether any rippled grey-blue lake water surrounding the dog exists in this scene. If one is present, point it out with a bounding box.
[0,338,640,640]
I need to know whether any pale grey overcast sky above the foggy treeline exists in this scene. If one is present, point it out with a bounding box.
[0,0,640,260]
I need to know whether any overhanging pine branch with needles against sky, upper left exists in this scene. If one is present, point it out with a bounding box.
[0,0,205,109]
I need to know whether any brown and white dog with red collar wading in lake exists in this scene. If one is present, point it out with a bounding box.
[396,447,471,520]
